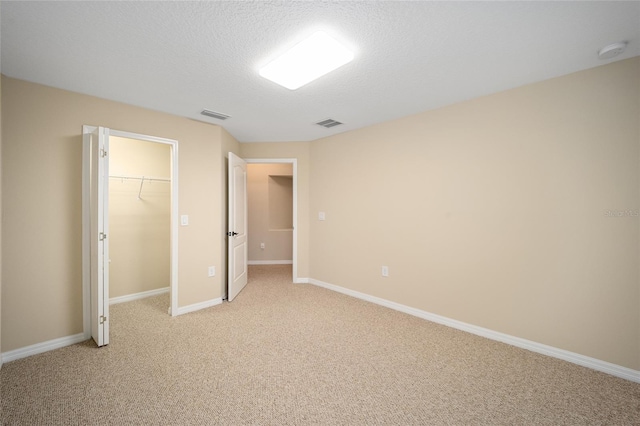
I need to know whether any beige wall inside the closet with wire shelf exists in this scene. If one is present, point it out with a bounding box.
[109,136,171,298]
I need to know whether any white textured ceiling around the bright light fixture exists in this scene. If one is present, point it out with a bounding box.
[0,1,640,142]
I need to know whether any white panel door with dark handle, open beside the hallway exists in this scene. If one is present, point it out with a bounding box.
[227,152,247,302]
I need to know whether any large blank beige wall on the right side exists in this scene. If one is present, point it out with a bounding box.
[309,58,640,369]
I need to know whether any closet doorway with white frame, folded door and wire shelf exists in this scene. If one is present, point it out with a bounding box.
[82,126,178,346]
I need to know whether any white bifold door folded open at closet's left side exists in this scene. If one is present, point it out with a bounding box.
[84,126,109,346]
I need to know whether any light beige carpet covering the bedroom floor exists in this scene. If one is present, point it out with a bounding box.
[0,266,640,425]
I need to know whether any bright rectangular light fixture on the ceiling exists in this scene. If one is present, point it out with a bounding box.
[260,31,353,90]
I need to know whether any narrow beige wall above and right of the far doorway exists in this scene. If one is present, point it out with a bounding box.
[240,142,311,278]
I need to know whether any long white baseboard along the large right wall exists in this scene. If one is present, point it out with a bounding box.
[307,278,640,383]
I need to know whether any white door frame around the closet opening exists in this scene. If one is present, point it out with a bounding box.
[82,125,179,339]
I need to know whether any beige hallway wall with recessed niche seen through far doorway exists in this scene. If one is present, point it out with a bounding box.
[247,163,293,262]
